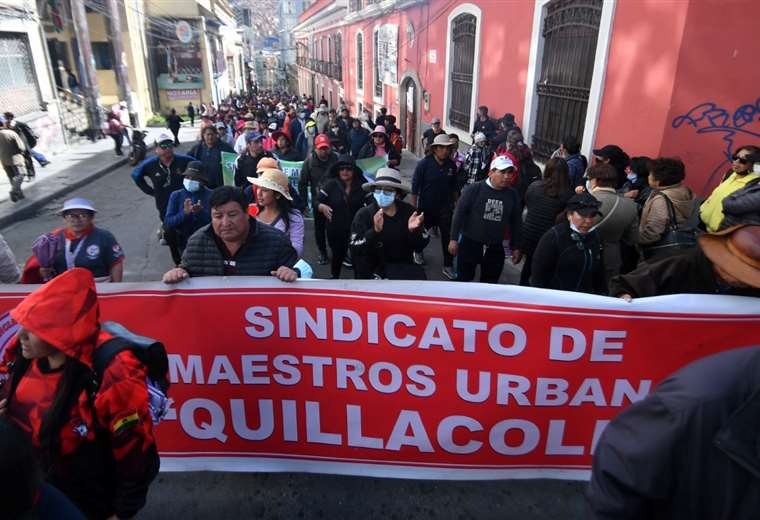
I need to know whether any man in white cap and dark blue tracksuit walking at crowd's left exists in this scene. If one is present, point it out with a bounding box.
[132,132,193,261]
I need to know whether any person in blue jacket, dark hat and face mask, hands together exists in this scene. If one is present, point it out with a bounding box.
[164,161,211,256]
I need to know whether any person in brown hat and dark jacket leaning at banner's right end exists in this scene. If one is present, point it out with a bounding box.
[610,224,760,301]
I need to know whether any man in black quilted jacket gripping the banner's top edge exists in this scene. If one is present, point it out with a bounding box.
[163,186,299,283]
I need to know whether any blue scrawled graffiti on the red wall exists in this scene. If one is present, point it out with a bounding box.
[672,98,760,187]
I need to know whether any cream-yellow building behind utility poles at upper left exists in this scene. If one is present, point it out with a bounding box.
[42,0,243,126]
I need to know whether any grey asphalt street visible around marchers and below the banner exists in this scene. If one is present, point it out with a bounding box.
[2,152,587,520]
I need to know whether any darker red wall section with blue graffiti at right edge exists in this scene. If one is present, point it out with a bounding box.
[660,0,760,195]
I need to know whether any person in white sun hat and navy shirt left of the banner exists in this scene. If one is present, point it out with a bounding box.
[33,198,124,282]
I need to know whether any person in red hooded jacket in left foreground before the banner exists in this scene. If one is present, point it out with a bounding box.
[0,268,159,519]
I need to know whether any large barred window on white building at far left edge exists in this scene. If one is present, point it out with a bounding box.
[0,33,42,116]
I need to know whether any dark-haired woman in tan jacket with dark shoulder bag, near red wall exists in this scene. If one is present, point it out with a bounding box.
[639,157,699,261]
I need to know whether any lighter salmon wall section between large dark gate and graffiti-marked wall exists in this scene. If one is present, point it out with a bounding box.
[594,0,688,157]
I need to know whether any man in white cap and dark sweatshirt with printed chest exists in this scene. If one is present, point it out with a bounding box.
[448,155,522,283]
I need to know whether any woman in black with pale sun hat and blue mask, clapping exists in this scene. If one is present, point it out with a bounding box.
[350,168,430,280]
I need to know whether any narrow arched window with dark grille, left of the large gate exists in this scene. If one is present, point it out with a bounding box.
[448,14,478,132]
